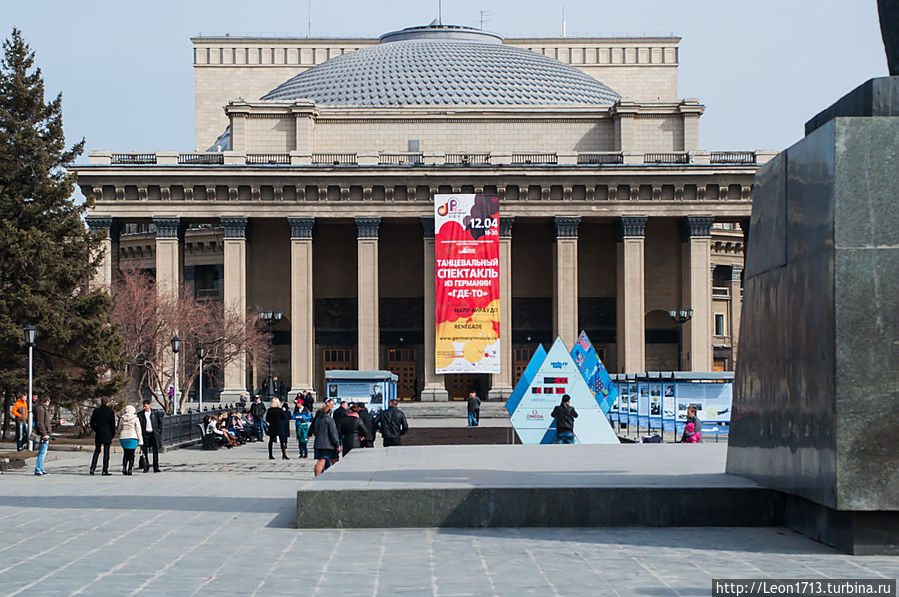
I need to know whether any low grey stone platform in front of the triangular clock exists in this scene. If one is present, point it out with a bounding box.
[297,444,783,528]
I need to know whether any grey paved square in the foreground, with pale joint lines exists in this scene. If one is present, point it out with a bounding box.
[0,443,899,596]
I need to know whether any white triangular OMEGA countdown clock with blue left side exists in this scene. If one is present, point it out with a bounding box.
[506,338,619,444]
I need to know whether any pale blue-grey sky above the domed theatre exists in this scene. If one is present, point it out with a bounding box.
[0,0,887,157]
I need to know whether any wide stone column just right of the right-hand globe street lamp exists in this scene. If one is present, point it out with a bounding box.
[681,216,714,371]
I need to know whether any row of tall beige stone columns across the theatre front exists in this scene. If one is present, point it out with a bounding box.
[87,215,716,400]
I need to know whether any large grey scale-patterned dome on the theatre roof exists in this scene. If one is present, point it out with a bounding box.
[261,25,621,106]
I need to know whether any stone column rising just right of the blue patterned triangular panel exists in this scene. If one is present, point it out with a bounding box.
[616,216,646,373]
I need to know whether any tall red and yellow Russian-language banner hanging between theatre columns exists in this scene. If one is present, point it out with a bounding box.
[434,194,509,374]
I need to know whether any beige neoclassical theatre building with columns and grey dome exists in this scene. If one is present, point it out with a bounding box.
[75,24,772,400]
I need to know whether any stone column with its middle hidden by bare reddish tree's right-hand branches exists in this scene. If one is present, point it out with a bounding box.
[222,217,247,402]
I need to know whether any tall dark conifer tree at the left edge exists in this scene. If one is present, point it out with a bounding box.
[0,29,121,428]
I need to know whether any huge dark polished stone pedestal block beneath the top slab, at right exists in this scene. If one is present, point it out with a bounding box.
[727,117,899,551]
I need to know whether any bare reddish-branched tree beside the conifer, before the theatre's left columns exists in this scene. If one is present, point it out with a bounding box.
[113,270,268,412]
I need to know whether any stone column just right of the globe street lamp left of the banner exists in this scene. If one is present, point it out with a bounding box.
[287,218,315,392]
